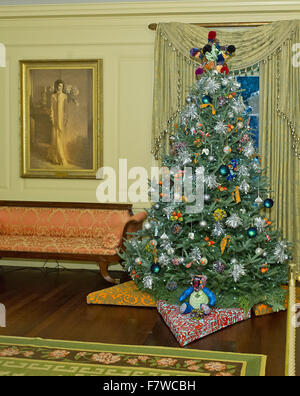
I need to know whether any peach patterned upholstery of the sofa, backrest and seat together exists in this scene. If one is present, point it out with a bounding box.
[0,206,134,255]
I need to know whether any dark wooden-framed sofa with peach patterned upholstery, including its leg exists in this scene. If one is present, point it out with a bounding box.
[0,201,147,283]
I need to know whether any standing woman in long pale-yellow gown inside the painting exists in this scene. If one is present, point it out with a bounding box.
[48,80,68,166]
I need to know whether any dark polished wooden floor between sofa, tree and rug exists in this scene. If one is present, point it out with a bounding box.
[0,267,300,376]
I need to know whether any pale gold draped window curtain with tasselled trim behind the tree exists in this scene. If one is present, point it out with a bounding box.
[152,20,300,274]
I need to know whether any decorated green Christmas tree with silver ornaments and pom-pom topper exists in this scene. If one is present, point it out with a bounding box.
[121,32,290,311]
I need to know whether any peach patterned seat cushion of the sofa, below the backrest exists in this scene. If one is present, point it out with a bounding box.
[0,234,116,256]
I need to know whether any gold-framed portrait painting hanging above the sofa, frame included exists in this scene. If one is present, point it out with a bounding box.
[20,59,103,179]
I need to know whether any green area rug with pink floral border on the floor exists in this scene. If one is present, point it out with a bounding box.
[0,336,266,376]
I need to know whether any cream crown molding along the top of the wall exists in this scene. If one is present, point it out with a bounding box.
[0,0,300,22]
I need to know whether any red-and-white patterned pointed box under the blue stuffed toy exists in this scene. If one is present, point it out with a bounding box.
[157,300,251,346]
